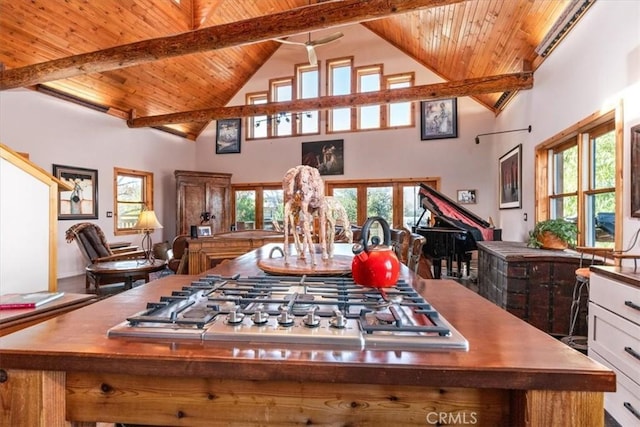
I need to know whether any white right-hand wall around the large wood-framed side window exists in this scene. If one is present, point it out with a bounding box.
[498,0,640,253]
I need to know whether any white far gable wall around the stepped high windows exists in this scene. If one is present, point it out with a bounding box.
[197,25,498,219]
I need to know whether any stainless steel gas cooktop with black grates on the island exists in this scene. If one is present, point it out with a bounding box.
[108,275,469,351]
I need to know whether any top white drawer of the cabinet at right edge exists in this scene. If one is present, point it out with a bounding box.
[589,272,640,325]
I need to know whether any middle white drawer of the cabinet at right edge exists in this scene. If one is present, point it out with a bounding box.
[589,303,640,385]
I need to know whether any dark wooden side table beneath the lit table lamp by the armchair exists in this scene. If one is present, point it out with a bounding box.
[86,259,167,294]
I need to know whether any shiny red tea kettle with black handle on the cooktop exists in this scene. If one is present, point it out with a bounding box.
[351,216,400,288]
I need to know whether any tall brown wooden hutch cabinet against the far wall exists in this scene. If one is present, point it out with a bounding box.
[175,170,231,235]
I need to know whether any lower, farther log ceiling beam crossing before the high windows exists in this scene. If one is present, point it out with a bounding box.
[127,72,533,128]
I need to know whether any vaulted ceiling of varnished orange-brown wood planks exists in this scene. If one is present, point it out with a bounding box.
[0,0,585,140]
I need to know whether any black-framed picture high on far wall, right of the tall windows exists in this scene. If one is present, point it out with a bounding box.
[420,98,458,141]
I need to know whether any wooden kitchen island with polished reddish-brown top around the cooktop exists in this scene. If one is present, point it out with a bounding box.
[0,244,615,427]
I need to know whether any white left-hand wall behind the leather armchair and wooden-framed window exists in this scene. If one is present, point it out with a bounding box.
[0,89,196,277]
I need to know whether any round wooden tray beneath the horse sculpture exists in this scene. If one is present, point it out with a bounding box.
[258,254,353,276]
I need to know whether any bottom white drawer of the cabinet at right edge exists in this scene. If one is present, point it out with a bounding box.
[589,349,640,426]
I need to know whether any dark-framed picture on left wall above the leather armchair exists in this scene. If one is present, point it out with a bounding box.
[53,165,98,220]
